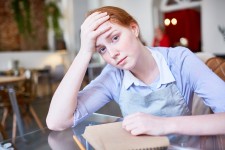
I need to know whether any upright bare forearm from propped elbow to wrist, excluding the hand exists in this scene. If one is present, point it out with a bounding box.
[46,51,92,130]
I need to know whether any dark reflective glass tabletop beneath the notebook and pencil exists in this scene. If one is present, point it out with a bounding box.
[0,113,225,150]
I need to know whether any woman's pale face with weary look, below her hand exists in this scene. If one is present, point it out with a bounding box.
[96,21,140,70]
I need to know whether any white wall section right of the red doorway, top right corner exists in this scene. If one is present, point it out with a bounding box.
[201,0,225,54]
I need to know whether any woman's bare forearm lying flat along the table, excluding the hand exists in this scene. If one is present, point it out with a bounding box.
[165,113,225,135]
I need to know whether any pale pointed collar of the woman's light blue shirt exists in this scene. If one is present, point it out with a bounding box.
[123,48,175,89]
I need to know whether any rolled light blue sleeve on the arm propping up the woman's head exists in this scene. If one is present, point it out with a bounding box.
[73,66,121,127]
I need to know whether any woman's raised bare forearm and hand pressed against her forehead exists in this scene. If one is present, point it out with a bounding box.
[46,12,111,130]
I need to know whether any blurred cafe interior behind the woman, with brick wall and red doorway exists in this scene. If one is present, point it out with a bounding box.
[0,0,225,149]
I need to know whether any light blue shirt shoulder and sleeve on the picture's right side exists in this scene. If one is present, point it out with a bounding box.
[155,47,225,113]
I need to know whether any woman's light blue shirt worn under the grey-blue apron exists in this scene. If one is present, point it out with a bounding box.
[74,47,225,126]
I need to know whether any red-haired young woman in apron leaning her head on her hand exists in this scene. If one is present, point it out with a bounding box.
[47,6,225,135]
